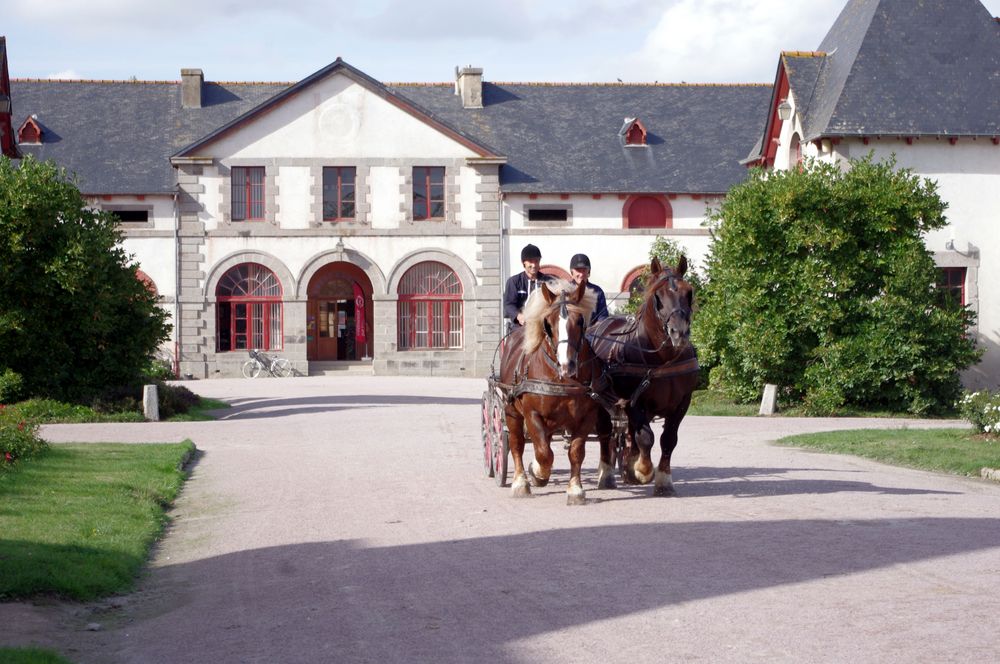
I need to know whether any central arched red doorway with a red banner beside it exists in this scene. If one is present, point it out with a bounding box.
[306,262,373,361]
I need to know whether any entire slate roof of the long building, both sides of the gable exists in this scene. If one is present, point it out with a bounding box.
[12,73,771,194]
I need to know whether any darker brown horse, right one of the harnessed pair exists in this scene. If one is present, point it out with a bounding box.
[587,256,698,496]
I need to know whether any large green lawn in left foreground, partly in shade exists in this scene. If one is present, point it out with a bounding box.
[0,441,195,600]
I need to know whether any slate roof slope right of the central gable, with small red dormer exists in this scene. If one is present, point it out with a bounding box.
[387,82,771,193]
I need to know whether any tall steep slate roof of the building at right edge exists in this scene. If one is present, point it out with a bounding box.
[782,0,1000,140]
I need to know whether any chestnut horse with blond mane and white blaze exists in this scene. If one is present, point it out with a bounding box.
[500,282,601,505]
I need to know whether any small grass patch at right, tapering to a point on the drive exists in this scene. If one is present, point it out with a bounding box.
[778,429,1000,477]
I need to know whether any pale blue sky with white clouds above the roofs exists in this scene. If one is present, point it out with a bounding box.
[0,0,1000,83]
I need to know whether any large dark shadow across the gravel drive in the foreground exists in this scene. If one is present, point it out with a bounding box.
[43,515,1000,664]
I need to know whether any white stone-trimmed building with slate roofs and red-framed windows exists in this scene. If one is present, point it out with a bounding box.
[0,0,1000,388]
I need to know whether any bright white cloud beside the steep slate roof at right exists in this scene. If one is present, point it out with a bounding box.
[625,0,844,83]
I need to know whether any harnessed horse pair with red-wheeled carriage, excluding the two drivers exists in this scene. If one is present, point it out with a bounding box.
[481,258,698,504]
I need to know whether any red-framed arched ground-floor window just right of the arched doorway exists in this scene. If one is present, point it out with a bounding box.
[397,261,462,350]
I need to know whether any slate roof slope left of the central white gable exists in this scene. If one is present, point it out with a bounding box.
[11,79,288,194]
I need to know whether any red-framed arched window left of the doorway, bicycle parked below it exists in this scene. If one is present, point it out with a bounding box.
[215,263,282,352]
